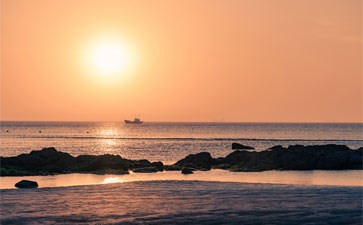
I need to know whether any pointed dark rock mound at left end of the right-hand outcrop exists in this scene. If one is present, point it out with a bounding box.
[174,152,214,170]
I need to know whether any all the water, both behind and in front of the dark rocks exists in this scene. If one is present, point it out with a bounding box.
[0,121,363,225]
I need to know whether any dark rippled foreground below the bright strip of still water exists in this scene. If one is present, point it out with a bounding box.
[1,180,363,224]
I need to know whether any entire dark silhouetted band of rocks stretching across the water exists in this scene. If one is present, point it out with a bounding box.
[0,144,363,176]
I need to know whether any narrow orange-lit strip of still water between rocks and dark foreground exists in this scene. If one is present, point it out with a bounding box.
[0,170,363,189]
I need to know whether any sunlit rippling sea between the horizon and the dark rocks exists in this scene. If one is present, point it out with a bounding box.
[0,122,363,163]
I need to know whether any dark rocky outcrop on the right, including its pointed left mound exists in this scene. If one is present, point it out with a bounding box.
[175,144,363,172]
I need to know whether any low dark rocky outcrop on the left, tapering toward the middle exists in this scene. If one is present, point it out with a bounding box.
[0,148,164,176]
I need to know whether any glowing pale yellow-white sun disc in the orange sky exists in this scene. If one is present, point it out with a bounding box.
[84,38,133,80]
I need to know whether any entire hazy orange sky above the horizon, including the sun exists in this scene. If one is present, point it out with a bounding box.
[0,0,363,122]
